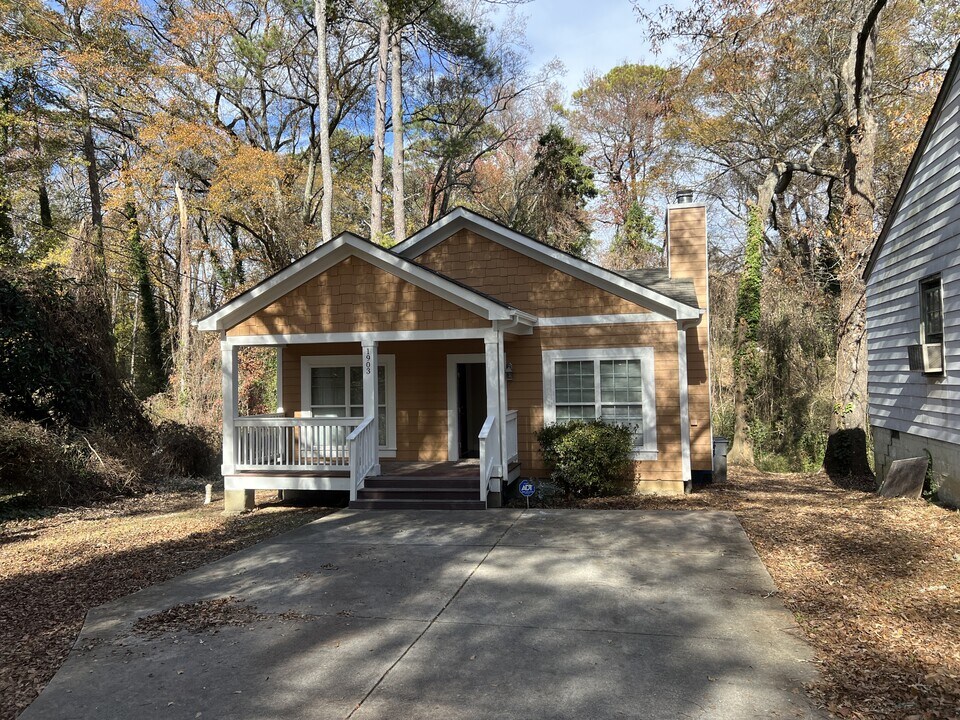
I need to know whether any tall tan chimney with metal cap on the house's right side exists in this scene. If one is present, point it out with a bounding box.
[665,190,713,481]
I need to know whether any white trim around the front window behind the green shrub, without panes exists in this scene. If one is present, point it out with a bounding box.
[543,347,658,460]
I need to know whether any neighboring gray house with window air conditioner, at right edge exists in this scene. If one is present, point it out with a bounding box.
[864,42,960,506]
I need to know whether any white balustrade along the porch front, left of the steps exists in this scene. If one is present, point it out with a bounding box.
[234,415,363,471]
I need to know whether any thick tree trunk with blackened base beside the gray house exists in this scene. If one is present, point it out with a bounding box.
[823,5,886,476]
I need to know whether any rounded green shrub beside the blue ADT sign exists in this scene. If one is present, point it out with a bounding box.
[537,420,633,497]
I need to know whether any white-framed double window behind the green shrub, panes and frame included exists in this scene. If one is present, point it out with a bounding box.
[543,347,657,460]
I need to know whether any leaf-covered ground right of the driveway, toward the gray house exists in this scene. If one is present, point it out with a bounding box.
[575,469,960,719]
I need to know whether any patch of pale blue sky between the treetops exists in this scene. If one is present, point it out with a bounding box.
[519,0,686,98]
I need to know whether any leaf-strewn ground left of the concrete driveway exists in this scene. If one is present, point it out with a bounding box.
[0,491,333,720]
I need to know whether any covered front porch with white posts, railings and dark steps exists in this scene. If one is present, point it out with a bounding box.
[222,335,520,509]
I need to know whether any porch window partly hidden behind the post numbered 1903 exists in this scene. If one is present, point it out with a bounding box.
[300,355,397,453]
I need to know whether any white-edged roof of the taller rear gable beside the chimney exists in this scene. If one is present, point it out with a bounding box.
[391,207,701,320]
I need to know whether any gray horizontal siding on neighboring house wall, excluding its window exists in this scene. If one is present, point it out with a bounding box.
[867,74,960,443]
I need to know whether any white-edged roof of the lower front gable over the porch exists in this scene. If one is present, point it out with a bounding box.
[197,233,535,331]
